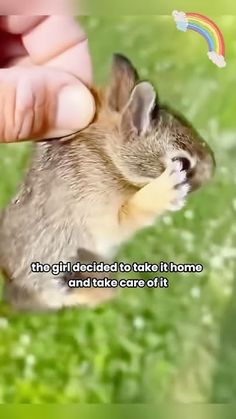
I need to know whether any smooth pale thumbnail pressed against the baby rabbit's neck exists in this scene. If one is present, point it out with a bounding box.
[56,83,95,131]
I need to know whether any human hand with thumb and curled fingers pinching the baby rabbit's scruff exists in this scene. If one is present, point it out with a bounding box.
[0,15,95,142]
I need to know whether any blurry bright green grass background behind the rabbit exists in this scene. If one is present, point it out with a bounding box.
[0,16,236,403]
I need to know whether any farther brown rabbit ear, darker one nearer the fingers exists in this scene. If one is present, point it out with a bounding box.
[108,54,138,112]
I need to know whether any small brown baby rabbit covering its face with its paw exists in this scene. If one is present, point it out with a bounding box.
[0,54,214,310]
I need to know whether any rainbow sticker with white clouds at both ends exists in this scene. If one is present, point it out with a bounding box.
[172,10,226,68]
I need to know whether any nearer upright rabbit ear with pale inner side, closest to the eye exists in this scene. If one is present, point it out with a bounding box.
[121,81,157,135]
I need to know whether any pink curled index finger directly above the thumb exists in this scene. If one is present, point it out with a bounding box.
[22,16,92,85]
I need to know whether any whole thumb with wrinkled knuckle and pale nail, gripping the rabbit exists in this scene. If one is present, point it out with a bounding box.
[0,67,95,142]
